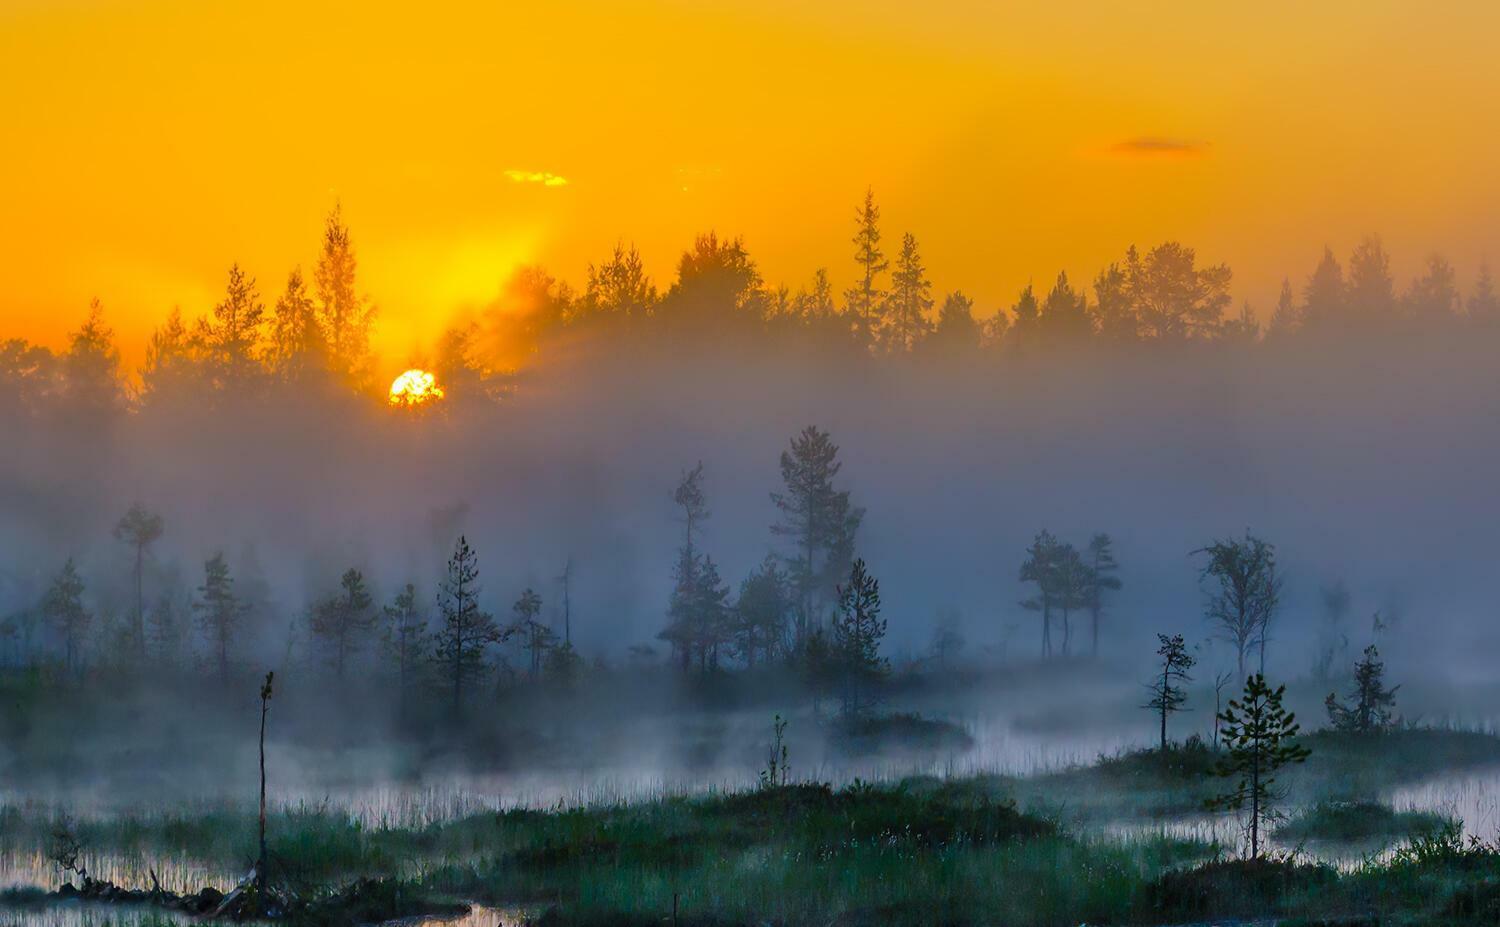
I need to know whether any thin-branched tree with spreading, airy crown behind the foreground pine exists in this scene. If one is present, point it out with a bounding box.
[1194,533,1281,678]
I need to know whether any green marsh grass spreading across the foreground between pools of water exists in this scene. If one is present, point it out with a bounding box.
[0,732,1500,927]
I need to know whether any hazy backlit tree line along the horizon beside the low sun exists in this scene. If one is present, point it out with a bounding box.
[0,191,1500,413]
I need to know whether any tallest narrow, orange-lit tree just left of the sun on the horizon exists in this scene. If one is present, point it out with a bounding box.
[312,206,375,387]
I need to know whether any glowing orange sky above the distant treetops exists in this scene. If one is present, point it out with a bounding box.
[0,0,1500,373]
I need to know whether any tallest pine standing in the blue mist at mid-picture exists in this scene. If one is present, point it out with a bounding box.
[771,425,864,645]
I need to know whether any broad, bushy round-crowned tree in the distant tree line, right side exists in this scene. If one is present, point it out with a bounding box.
[1124,242,1233,341]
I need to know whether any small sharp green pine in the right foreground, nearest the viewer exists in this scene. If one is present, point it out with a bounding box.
[1208,674,1311,860]
